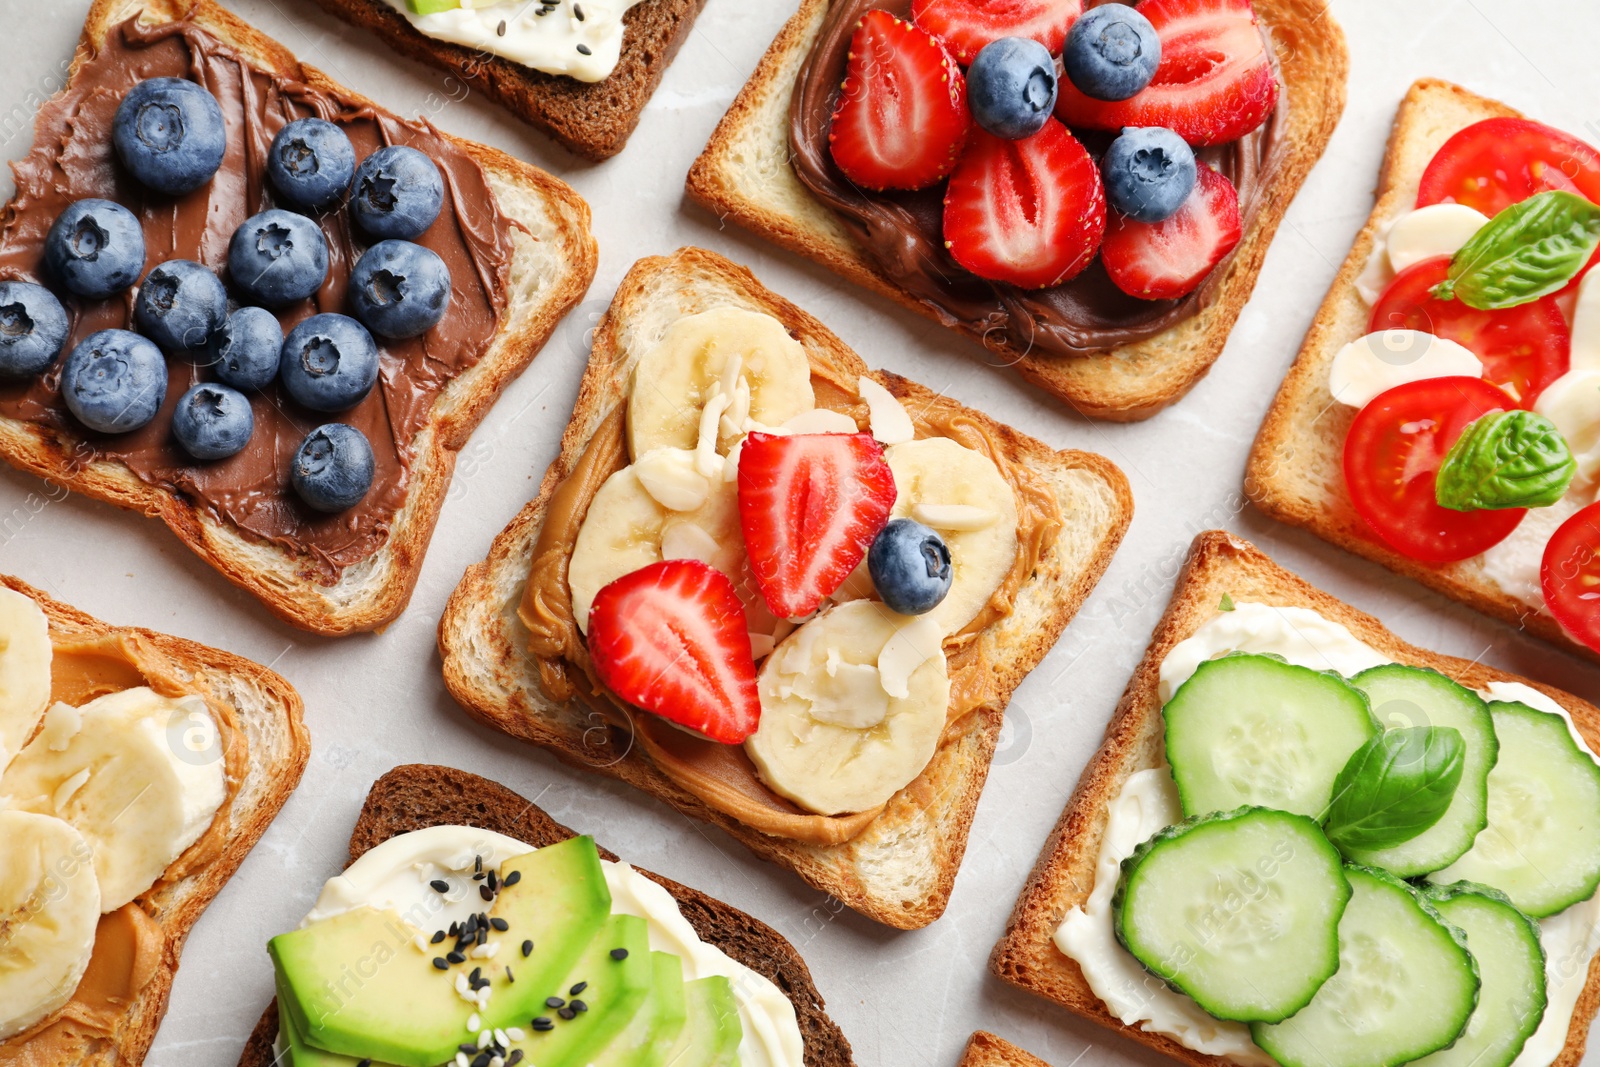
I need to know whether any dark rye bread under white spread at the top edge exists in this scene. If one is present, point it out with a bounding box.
[317,0,706,162]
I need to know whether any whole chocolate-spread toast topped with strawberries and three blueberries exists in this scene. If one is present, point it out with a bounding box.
[688,0,1347,421]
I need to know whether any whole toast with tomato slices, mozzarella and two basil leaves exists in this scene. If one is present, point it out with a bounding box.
[1245,80,1600,668]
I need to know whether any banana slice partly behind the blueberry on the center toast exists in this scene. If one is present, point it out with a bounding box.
[883,437,1018,633]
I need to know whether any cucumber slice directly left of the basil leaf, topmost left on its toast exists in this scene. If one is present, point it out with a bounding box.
[1162,653,1379,819]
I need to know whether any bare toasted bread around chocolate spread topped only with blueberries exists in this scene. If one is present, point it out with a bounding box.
[0,0,598,635]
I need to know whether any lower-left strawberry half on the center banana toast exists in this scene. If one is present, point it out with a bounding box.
[589,560,762,745]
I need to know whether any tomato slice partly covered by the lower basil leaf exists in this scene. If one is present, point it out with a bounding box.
[1344,378,1526,563]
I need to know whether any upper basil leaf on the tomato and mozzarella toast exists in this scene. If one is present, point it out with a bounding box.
[1434,190,1600,310]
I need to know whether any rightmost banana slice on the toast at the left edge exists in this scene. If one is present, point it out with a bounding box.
[0,688,227,912]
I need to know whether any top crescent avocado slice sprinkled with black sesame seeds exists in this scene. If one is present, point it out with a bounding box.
[267,837,608,1067]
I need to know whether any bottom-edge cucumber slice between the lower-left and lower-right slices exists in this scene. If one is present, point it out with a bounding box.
[1250,864,1478,1067]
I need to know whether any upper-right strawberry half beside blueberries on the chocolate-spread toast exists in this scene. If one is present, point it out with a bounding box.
[1056,0,1278,144]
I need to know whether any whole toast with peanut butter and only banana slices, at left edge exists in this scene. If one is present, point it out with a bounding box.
[0,576,310,1067]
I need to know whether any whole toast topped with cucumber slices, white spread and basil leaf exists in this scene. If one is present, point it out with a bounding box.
[990,531,1600,1067]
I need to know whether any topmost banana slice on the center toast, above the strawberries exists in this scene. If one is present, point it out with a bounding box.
[627,307,816,459]
